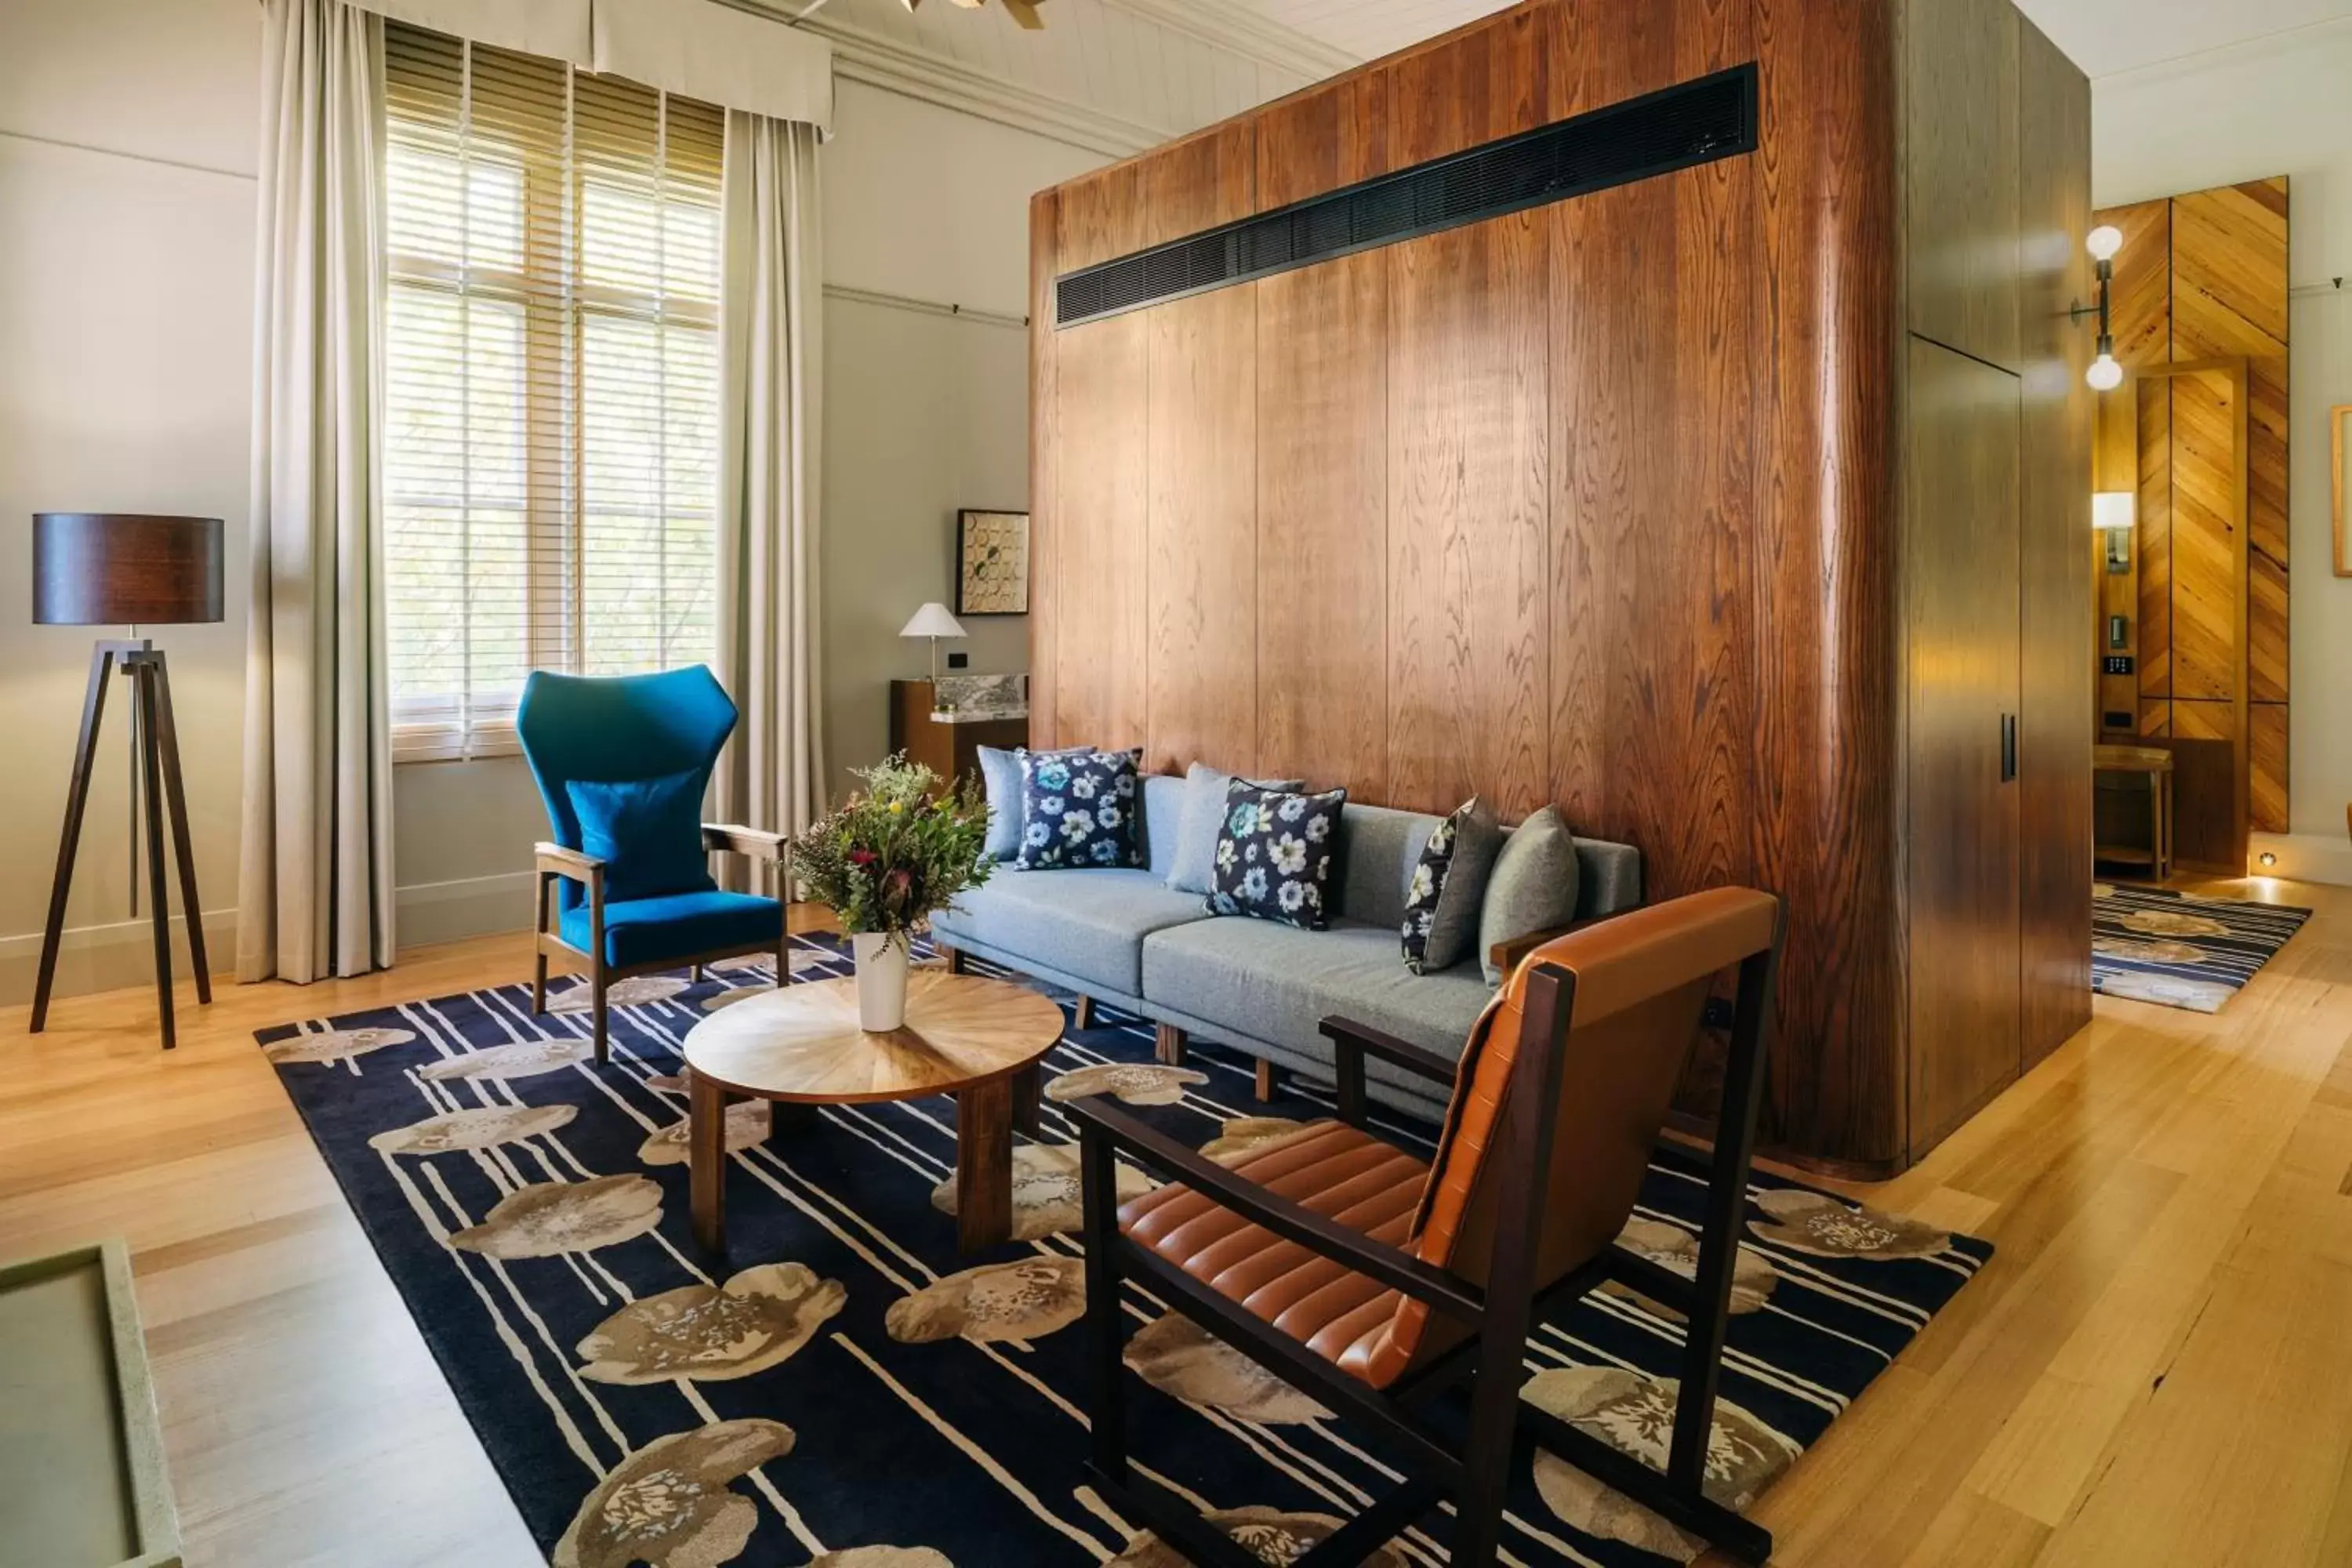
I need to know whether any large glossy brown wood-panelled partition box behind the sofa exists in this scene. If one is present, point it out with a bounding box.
[1030,0,2091,1171]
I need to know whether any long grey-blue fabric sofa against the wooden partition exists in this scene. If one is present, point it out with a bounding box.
[931,776,1642,1112]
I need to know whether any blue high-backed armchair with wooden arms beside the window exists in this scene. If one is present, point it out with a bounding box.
[515,666,790,1062]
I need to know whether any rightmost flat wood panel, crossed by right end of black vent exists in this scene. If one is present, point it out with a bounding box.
[1545,0,1759,898]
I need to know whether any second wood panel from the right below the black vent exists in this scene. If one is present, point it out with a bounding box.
[1388,212,1550,820]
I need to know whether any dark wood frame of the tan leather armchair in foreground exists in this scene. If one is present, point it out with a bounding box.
[1068,924,1780,1568]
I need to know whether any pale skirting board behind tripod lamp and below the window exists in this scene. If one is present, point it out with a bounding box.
[0,872,532,1011]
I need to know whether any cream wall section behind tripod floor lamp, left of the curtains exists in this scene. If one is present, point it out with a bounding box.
[0,0,259,1001]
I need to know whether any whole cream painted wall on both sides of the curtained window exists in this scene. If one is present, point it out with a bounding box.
[0,0,1101,1004]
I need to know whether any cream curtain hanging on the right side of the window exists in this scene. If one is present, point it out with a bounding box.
[717,111,826,891]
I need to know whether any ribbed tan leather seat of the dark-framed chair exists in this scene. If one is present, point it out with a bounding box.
[1120,1121,1430,1387]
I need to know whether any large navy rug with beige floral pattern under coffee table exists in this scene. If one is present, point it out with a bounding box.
[259,938,1992,1568]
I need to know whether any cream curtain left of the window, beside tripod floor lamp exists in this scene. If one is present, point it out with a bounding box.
[238,0,393,982]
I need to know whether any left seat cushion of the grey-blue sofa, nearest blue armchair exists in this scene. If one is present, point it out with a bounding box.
[931,867,1214,996]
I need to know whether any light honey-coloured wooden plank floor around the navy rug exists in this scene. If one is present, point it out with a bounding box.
[0,884,2352,1568]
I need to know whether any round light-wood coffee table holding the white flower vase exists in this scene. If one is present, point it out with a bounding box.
[687,968,1061,1250]
